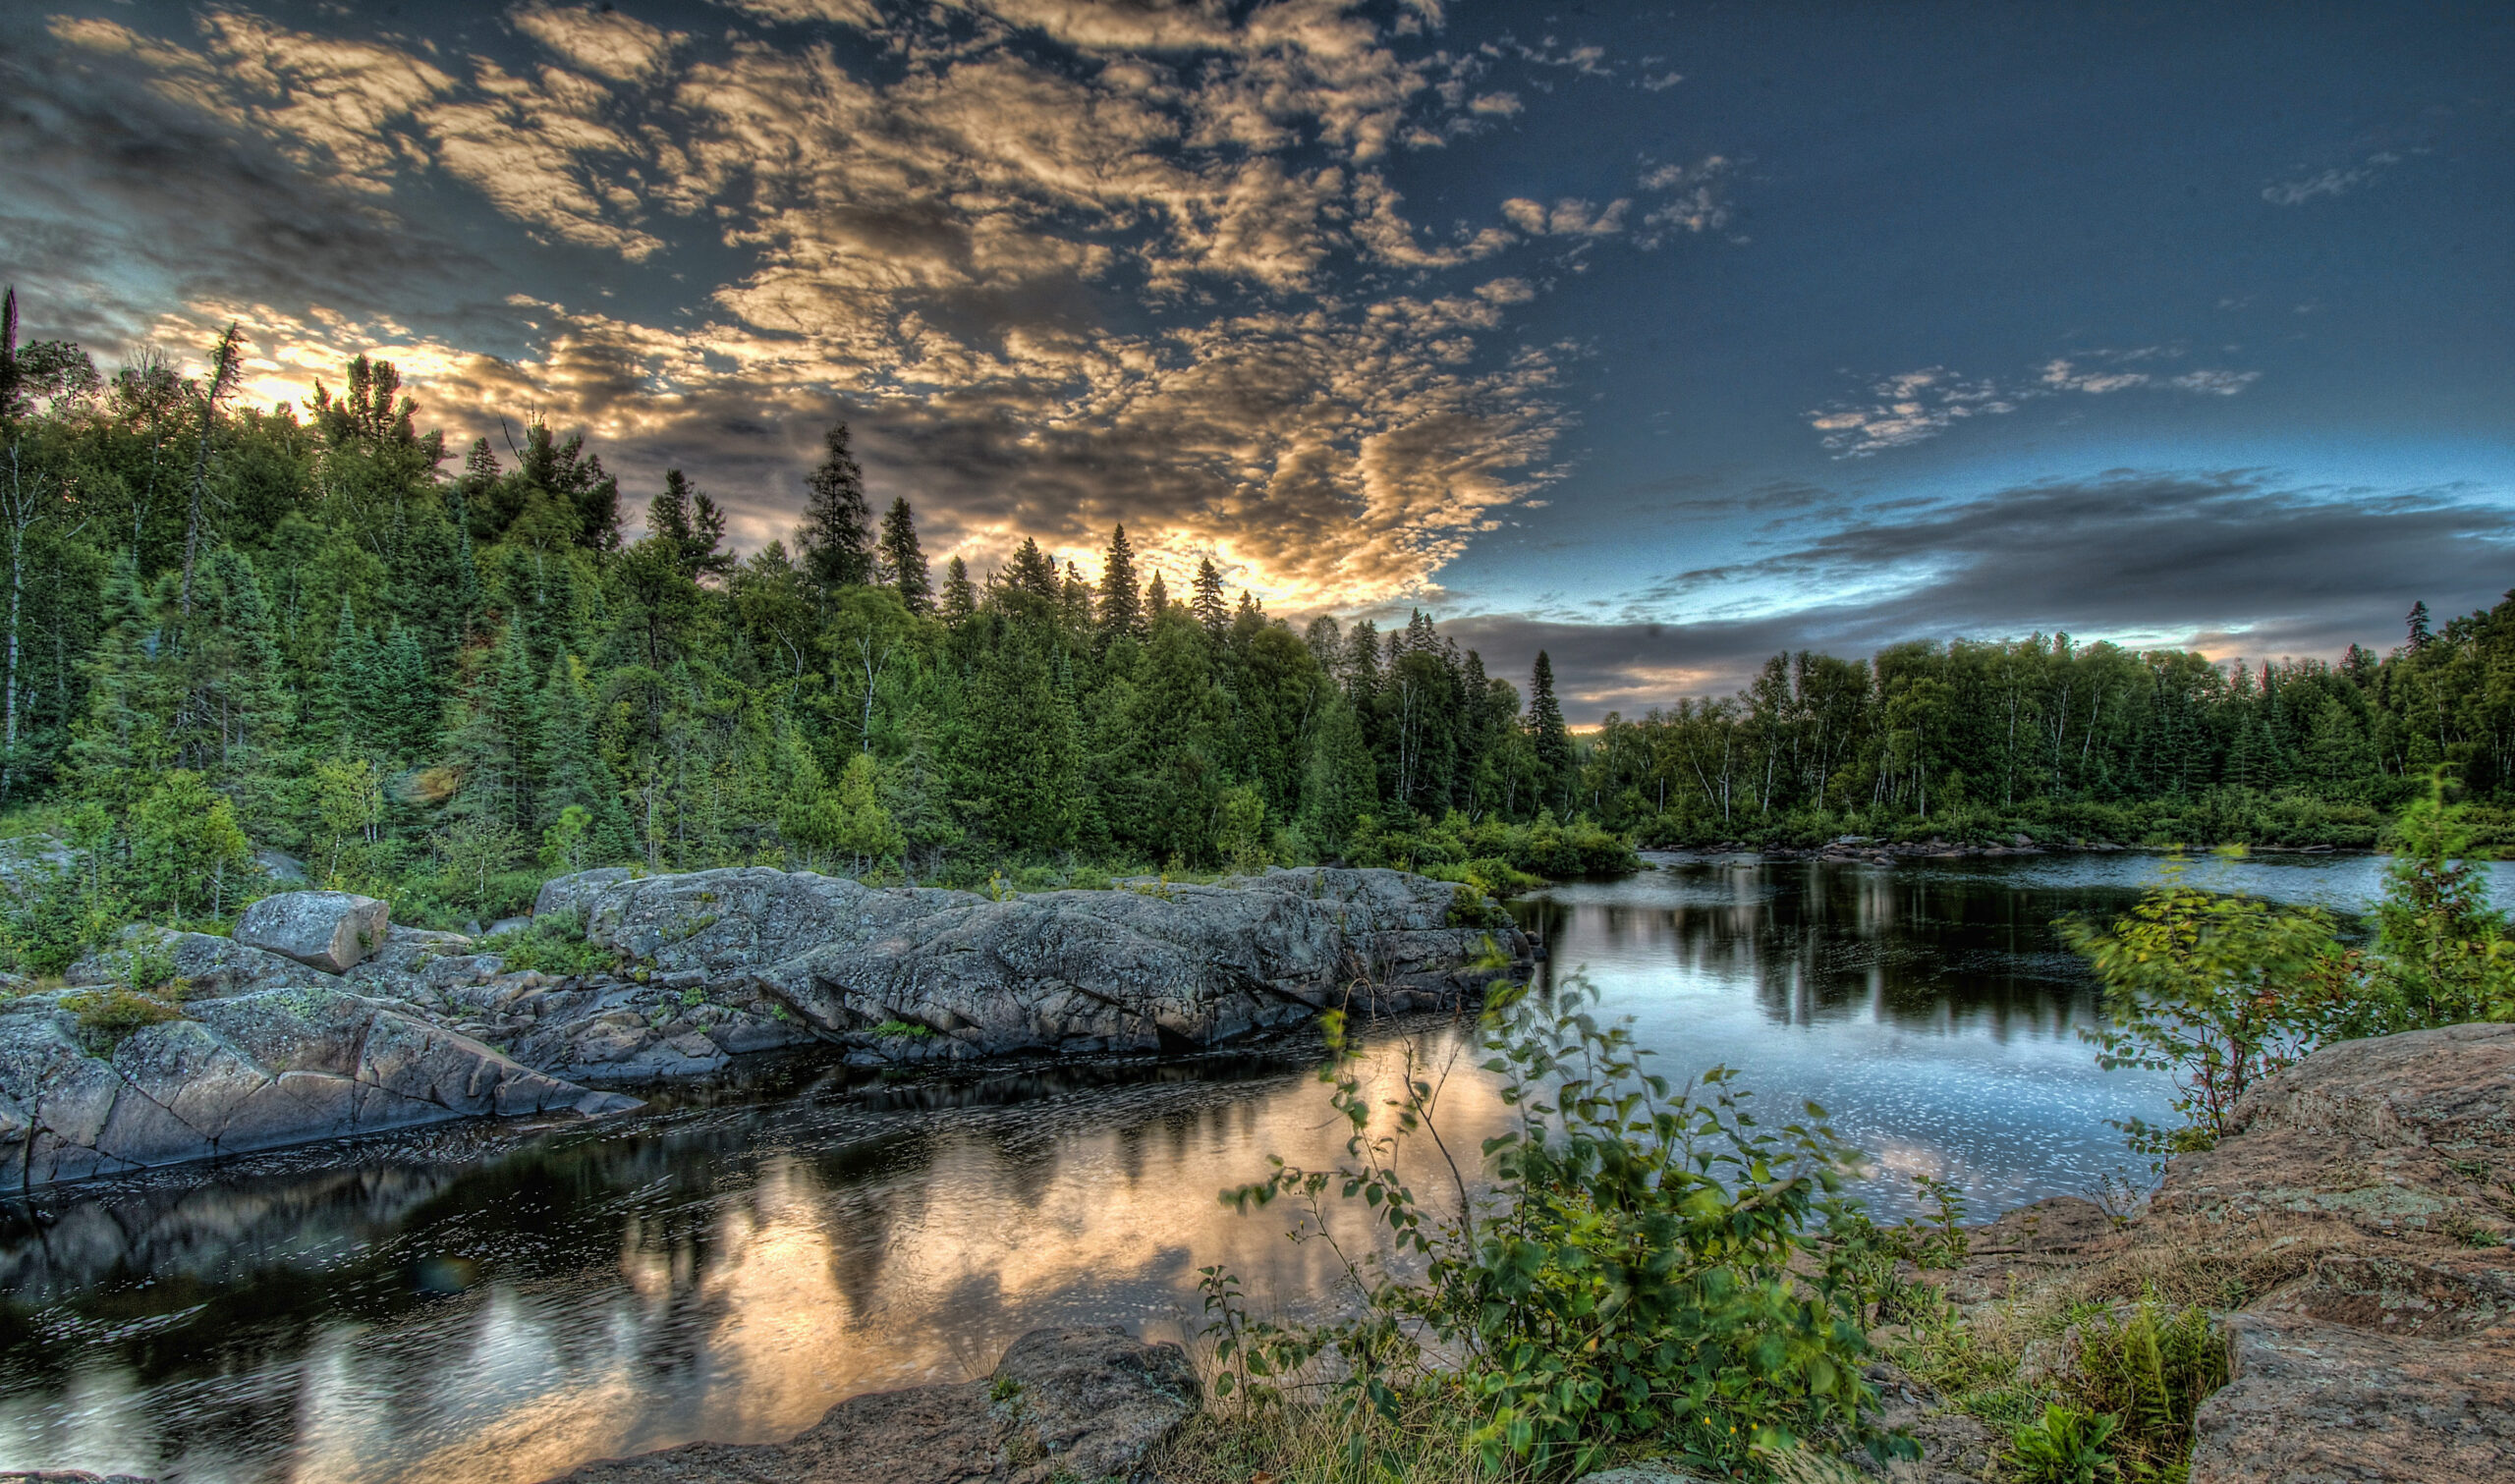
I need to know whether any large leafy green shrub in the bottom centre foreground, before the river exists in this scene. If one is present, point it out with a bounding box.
[1202,981,1872,1471]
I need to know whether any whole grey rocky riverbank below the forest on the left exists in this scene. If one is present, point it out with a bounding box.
[0,868,1529,1189]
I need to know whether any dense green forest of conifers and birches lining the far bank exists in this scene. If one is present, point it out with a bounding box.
[0,295,2515,968]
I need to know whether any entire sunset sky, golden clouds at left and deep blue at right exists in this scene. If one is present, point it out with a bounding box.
[0,0,2515,719]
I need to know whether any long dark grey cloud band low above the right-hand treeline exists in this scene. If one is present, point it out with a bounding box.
[1441,470,2515,722]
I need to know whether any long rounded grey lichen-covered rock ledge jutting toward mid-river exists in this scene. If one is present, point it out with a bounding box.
[546,868,1527,1059]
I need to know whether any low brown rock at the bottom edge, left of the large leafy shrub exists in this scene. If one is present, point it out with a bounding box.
[553,1326,1200,1484]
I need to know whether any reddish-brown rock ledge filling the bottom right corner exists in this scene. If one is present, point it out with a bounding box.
[2151,1026,2515,1484]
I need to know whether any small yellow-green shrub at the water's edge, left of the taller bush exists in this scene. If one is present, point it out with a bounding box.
[2060,860,2334,1157]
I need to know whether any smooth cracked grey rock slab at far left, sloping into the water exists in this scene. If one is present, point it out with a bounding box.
[0,986,637,1187]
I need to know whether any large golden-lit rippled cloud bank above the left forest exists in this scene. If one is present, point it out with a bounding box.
[15,0,1725,606]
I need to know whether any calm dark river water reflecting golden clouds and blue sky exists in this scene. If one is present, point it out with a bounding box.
[0,855,2505,1484]
